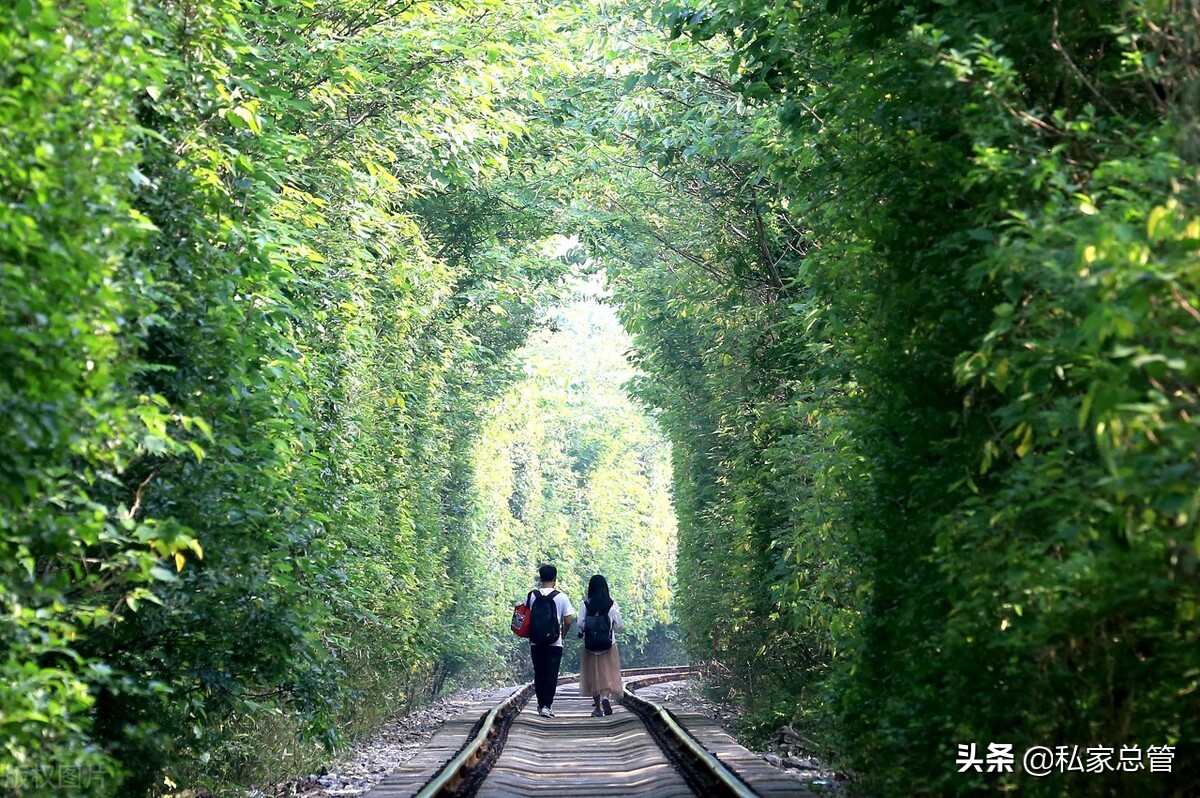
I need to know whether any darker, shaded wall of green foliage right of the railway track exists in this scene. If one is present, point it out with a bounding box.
[592,0,1200,796]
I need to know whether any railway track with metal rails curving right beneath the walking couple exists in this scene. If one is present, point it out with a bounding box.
[365,667,812,798]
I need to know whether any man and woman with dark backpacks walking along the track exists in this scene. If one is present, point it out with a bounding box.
[526,565,622,718]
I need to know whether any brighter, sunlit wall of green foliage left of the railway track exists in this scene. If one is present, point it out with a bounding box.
[0,0,580,796]
